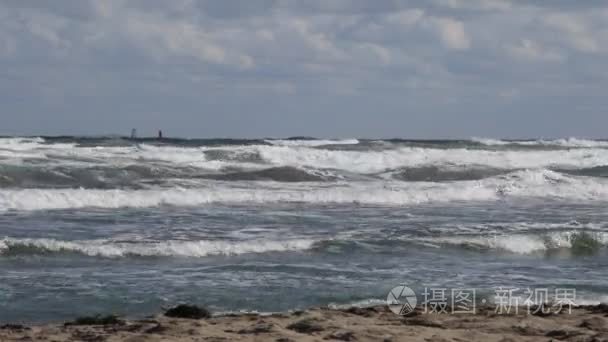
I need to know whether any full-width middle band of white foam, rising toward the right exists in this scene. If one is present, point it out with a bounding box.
[0,170,608,210]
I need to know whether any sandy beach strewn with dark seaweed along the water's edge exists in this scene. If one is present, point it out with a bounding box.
[0,305,608,342]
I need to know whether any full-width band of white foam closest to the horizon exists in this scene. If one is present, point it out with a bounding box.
[0,138,608,174]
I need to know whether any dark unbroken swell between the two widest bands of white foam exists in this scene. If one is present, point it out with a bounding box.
[7,161,608,190]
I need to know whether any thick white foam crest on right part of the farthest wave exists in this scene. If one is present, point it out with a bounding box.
[247,146,608,173]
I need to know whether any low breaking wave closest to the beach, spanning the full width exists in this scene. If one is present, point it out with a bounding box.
[0,230,608,258]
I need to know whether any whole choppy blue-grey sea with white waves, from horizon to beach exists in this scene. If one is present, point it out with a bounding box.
[0,137,608,322]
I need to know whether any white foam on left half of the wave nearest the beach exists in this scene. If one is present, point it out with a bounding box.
[0,237,315,257]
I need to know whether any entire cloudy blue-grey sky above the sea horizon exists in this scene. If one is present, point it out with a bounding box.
[0,0,608,138]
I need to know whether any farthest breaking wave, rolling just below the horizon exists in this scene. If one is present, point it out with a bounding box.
[0,138,608,180]
